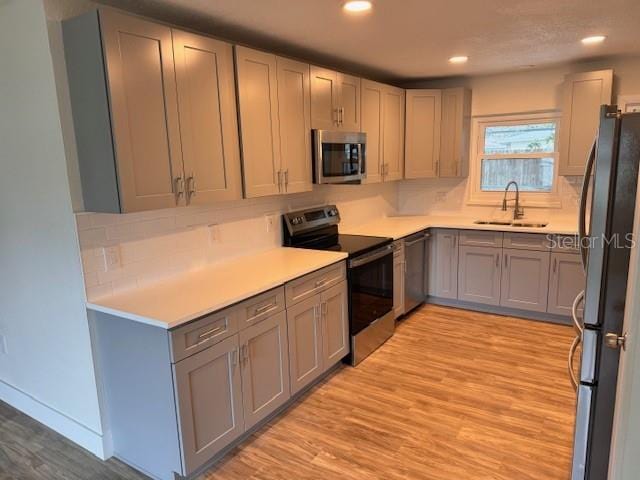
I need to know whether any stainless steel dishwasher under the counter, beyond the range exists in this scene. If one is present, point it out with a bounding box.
[404,232,429,313]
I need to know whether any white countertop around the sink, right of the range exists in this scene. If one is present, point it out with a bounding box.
[340,215,578,240]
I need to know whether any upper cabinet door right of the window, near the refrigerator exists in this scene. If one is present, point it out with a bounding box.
[558,70,613,175]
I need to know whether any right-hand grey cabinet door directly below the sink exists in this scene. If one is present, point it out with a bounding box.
[500,248,550,312]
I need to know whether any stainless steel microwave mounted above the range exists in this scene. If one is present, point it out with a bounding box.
[313,130,367,183]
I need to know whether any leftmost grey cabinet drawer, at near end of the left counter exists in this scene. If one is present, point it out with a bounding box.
[171,307,238,362]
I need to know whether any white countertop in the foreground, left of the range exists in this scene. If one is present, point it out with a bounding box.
[87,247,347,329]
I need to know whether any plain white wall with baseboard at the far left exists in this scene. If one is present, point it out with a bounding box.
[0,0,102,454]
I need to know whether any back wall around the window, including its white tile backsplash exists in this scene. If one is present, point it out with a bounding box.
[398,57,640,220]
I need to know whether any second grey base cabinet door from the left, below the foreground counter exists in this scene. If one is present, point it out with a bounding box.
[239,311,291,430]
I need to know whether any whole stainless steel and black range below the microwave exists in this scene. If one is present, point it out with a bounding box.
[282,205,395,366]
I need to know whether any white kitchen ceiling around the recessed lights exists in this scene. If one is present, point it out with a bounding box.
[97,0,640,82]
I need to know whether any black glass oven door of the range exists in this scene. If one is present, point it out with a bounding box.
[349,244,393,335]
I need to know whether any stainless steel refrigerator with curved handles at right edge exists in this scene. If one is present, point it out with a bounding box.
[569,106,640,480]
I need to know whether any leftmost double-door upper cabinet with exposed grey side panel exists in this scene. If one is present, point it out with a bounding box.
[63,9,241,213]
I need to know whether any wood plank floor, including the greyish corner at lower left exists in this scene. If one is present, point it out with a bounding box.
[0,305,575,480]
